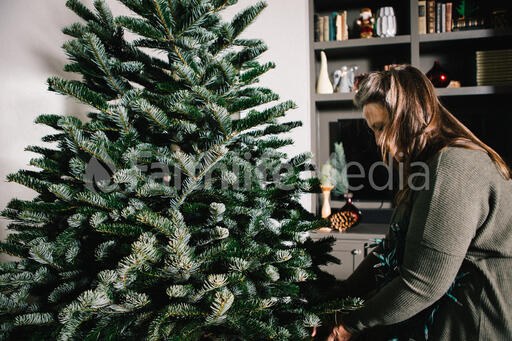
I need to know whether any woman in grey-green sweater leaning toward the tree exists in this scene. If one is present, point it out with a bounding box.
[313,65,512,341]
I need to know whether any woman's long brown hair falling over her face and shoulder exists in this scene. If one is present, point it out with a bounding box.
[354,64,511,205]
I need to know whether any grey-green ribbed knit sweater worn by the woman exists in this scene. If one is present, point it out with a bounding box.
[342,147,512,341]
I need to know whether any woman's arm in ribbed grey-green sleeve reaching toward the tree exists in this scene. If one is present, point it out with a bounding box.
[342,148,490,333]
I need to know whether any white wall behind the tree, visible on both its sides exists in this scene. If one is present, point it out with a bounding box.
[0,0,311,258]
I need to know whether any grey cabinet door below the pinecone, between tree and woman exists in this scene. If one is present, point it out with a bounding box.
[322,240,368,279]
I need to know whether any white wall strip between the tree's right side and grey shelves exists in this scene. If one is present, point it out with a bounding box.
[220,0,312,205]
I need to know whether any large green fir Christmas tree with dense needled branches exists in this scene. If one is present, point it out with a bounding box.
[0,0,361,340]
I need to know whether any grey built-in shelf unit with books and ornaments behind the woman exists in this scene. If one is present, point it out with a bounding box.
[308,0,512,218]
